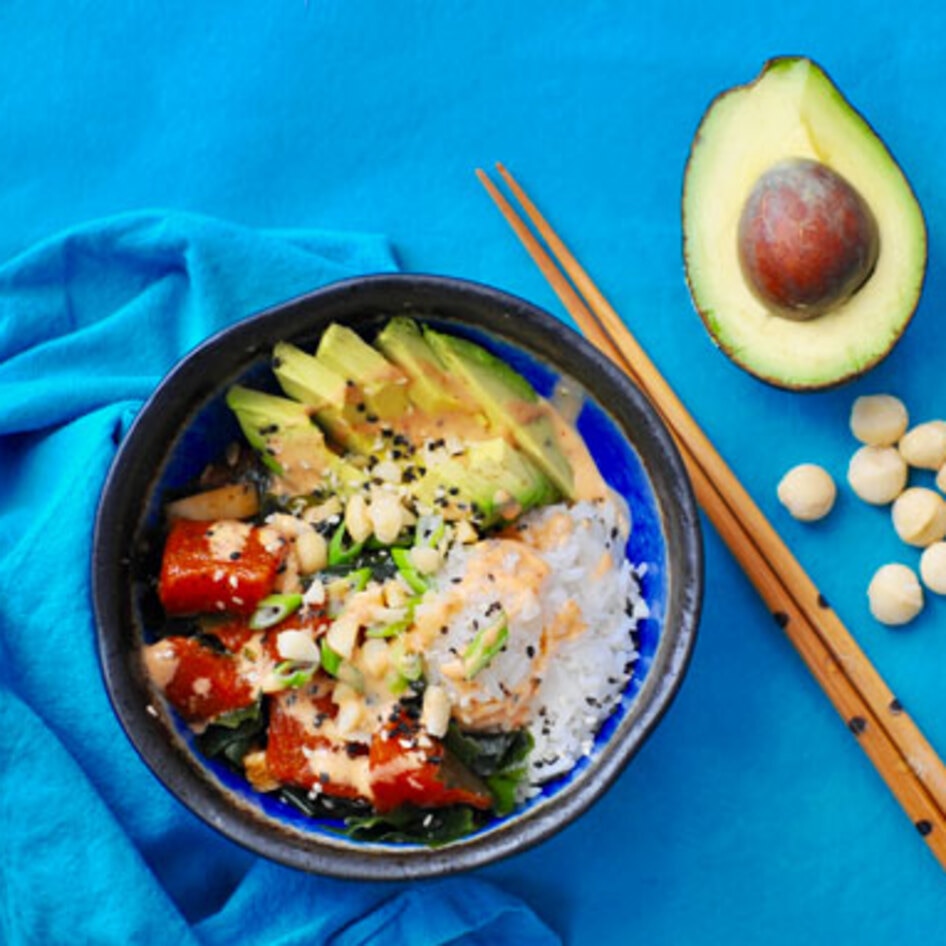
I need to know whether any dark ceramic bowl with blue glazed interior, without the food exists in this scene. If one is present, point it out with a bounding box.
[93,276,702,880]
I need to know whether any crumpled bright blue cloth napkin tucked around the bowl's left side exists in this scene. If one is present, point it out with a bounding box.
[0,212,558,946]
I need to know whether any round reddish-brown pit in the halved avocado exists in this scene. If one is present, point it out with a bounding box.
[738,158,880,321]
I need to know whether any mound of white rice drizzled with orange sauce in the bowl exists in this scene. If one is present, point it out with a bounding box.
[423,496,648,794]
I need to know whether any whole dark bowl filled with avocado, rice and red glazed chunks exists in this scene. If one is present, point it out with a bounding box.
[92,275,702,880]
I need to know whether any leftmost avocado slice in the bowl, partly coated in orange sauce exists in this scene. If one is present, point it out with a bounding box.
[226,384,364,495]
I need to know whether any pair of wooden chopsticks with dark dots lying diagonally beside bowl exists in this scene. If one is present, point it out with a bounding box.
[476,164,946,868]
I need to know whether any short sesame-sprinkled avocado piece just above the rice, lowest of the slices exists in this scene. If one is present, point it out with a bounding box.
[414,437,560,527]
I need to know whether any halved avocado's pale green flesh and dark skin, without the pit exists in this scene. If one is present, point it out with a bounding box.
[683,57,927,390]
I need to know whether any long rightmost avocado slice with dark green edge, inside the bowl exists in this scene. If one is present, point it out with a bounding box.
[424,327,575,499]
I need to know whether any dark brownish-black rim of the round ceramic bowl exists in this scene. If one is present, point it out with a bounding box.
[91,273,703,880]
